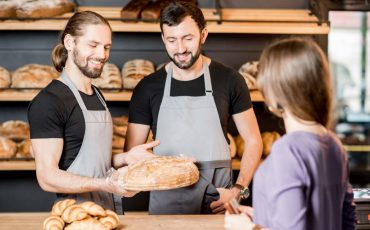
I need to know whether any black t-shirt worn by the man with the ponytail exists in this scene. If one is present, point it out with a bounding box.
[28,80,105,170]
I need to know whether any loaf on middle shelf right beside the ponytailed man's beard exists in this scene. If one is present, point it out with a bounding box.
[92,63,122,89]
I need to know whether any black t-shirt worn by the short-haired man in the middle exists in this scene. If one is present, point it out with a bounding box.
[129,61,252,140]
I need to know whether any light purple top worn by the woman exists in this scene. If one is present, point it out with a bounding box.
[253,131,356,230]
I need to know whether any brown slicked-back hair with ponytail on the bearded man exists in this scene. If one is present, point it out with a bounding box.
[51,11,112,72]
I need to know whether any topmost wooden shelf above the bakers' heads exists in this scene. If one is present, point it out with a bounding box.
[0,6,329,34]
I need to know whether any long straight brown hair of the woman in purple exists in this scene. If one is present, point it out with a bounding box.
[257,37,332,127]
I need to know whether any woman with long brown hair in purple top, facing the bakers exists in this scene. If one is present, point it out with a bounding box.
[225,37,355,230]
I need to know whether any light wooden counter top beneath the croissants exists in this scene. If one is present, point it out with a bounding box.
[0,212,224,230]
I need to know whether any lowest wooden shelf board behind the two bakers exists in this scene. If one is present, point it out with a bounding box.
[0,159,240,171]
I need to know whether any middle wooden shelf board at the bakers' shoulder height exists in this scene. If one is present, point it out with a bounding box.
[0,90,263,102]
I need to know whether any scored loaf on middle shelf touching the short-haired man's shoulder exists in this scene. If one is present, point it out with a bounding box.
[122,59,155,89]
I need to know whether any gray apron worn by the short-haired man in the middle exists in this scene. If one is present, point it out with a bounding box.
[149,59,232,215]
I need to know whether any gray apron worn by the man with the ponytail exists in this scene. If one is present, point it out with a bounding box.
[57,72,115,210]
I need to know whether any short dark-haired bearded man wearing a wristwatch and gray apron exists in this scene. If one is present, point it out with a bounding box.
[125,2,262,214]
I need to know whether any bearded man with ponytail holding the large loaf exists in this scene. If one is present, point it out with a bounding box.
[28,11,158,212]
